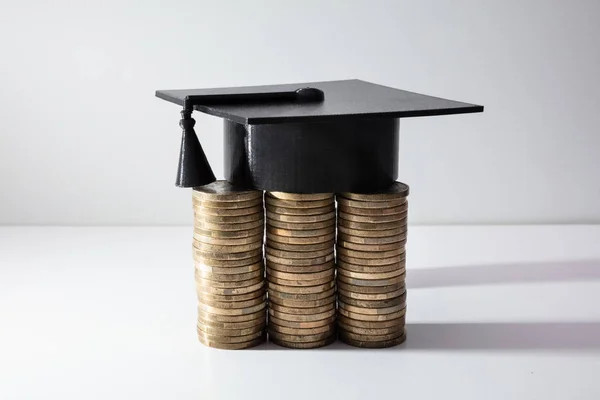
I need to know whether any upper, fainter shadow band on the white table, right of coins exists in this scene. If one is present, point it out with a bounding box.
[406,260,600,289]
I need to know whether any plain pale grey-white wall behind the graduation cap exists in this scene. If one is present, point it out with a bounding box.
[0,0,600,225]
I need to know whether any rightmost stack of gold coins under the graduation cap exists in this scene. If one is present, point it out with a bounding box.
[337,182,409,348]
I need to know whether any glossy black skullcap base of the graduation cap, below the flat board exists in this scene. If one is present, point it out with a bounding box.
[224,118,399,193]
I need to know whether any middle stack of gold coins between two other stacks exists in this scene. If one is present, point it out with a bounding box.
[265,192,336,348]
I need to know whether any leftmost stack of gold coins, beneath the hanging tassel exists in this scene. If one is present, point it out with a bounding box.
[193,181,266,349]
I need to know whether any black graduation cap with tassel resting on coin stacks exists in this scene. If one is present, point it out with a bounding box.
[156,80,483,193]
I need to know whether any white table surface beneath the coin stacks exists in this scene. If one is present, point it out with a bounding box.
[0,226,600,400]
